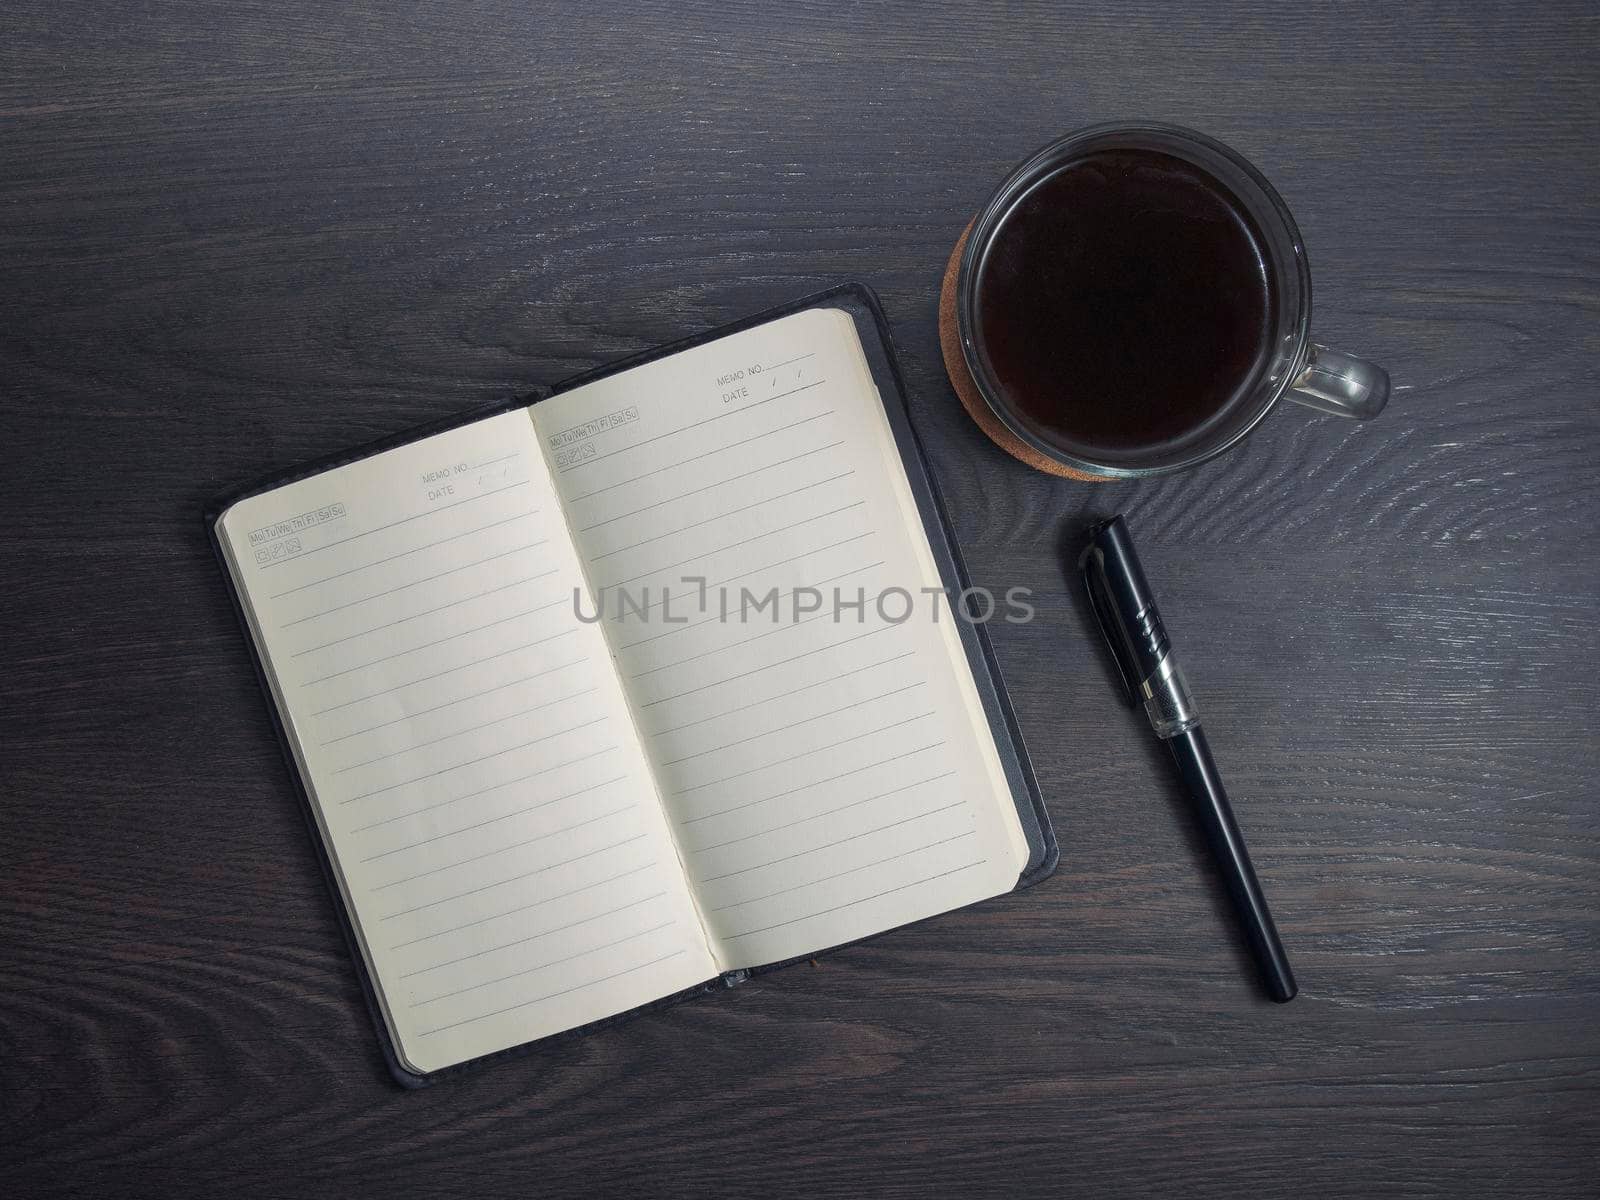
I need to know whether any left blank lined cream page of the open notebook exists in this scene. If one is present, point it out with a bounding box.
[212,411,715,1070]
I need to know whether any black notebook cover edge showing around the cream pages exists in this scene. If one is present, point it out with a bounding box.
[205,283,1059,1088]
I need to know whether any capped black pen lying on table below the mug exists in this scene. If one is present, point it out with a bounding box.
[1078,515,1299,1003]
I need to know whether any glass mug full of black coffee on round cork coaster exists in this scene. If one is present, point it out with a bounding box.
[955,125,1389,478]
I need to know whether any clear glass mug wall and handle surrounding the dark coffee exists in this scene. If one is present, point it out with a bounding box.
[955,123,1389,480]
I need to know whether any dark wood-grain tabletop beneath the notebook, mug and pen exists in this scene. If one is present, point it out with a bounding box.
[0,0,1600,1200]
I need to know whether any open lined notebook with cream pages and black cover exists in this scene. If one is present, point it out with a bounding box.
[211,290,1054,1082]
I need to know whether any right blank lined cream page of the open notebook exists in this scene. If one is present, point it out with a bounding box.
[531,310,1027,968]
